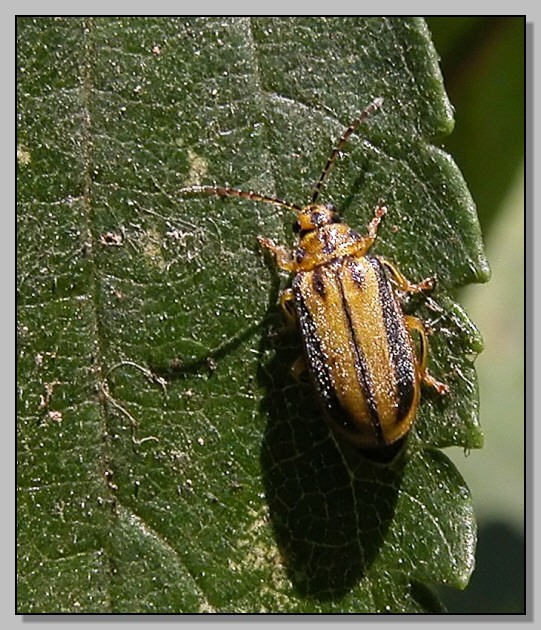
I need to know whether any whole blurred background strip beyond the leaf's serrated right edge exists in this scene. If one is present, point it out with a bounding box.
[427,17,526,613]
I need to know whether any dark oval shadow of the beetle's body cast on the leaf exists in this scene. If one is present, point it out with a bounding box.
[258,318,403,600]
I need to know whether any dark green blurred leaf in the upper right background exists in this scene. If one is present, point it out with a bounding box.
[427,16,526,236]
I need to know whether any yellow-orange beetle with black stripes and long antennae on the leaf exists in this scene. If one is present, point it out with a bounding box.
[181,98,449,449]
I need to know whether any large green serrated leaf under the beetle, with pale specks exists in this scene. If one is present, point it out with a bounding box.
[17,18,488,613]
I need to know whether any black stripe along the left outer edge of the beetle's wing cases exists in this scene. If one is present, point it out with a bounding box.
[292,272,359,435]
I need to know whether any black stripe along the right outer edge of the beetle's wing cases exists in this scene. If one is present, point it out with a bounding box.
[367,256,415,424]
